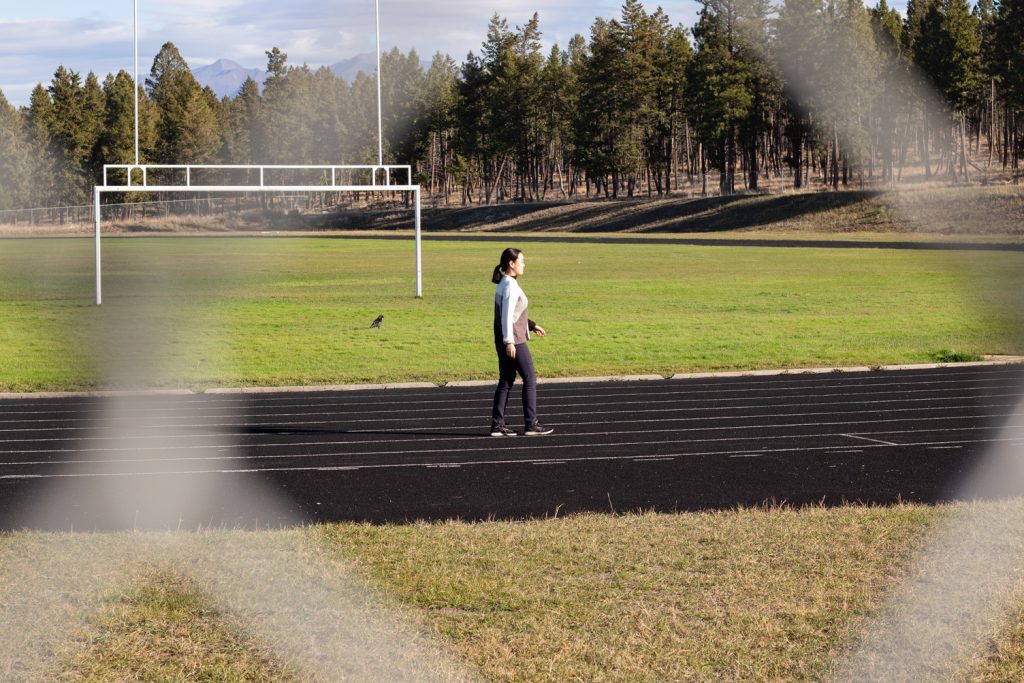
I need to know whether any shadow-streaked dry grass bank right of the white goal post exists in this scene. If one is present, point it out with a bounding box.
[417,186,1024,238]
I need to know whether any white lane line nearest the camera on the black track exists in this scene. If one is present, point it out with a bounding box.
[0,438,1015,479]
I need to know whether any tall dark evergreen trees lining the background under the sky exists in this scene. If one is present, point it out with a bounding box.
[0,0,1024,209]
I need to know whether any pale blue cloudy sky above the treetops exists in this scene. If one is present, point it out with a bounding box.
[0,0,712,105]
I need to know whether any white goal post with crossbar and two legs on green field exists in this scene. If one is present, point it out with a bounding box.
[92,164,423,305]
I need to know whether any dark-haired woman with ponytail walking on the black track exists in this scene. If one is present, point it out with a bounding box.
[490,248,554,436]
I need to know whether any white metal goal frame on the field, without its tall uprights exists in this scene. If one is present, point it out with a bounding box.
[92,164,423,305]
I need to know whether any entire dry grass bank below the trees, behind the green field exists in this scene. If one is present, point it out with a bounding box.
[0,183,1024,240]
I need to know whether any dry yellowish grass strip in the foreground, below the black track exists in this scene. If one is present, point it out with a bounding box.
[6,501,1024,681]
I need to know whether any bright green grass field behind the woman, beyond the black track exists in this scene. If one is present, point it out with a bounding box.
[0,238,1024,391]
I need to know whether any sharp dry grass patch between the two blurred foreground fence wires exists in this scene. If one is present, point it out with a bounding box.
[319,506,1021,681]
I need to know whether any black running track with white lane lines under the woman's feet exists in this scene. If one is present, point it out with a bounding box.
[0,366,1024,529]
